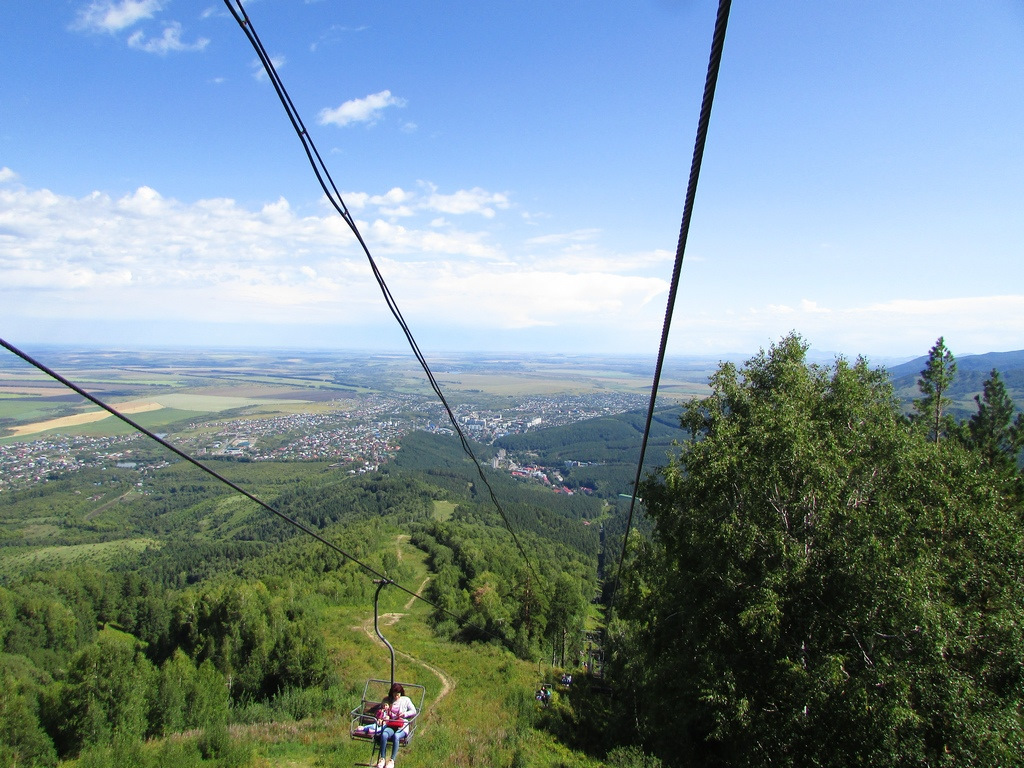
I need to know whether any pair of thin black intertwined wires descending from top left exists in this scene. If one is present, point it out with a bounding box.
[224,0,541,582]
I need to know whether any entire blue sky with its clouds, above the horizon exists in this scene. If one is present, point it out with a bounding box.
[0,0,1024,359]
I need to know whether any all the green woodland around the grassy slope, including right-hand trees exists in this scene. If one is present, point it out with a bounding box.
[0,335,1024,768]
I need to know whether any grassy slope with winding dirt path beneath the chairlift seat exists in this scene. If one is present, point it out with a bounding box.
[61,537,602,768]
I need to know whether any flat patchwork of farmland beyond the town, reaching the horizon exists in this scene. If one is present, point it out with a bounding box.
[0,347,717,443]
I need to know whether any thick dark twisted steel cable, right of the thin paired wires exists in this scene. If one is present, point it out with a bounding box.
[608,0,732,615]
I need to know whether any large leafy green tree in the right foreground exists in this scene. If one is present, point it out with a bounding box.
[607,335,1024,766]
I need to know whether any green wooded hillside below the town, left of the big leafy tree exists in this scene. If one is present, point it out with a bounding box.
[0,417,622,765]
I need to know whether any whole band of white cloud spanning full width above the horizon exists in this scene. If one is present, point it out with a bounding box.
[0,182,1024,355]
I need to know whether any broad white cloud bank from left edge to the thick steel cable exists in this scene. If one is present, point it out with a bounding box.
[0,180,667,346]
